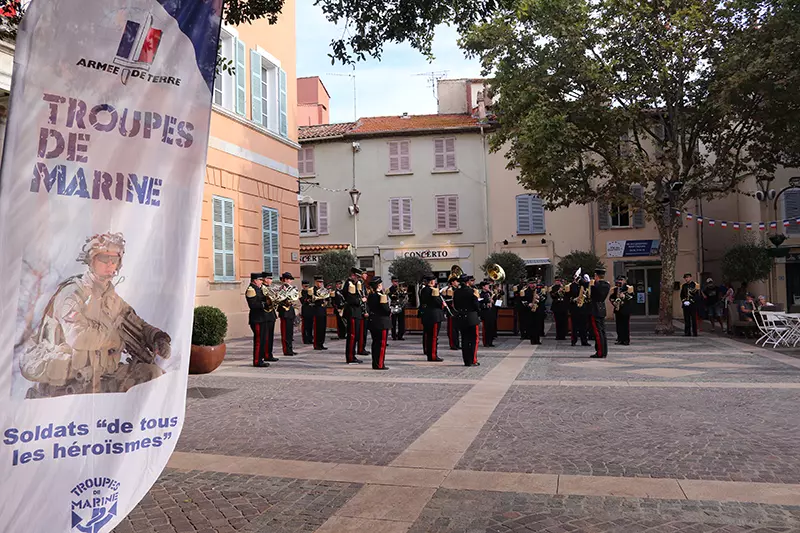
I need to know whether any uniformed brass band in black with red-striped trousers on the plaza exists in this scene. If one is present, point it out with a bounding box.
[245,265,644,370]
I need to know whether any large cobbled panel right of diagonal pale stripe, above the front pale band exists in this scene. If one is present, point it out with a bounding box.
[456,386,800,483]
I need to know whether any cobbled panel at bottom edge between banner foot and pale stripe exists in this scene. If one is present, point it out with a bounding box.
[113,470,361,533]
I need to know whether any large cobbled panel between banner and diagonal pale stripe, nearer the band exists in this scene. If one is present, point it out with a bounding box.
[177,374,470,465]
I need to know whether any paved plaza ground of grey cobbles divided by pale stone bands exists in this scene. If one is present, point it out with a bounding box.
[114,326,800,533]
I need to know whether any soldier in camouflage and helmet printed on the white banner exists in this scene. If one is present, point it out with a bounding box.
[19,233,171,398]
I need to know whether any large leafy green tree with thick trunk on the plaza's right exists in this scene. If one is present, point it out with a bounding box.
[462,0,800,333]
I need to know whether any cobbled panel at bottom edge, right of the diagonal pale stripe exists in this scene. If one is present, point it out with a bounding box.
[410,489,800,533]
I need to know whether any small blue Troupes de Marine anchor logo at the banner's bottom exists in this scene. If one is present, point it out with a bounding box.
[70,477,119,533]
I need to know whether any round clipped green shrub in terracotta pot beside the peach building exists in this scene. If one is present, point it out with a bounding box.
[189,305,228,374]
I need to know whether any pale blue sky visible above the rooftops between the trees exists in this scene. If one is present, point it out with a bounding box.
[296,0,480,123]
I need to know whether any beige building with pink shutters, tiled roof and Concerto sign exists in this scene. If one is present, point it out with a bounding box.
[300,114,489,281]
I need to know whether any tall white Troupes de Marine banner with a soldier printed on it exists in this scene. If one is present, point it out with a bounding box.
[0,0,222,533]
